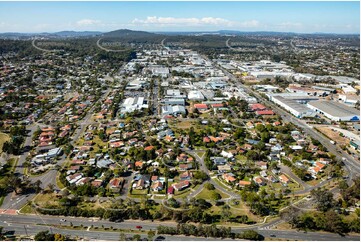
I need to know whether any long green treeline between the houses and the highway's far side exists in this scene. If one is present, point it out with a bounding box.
[37,197,253,224]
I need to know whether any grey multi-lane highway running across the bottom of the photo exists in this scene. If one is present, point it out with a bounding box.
[0,214,360,241]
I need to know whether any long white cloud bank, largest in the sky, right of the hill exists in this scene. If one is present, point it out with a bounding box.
[132,16,259,28]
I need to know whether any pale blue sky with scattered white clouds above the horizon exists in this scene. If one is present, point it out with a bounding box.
[0,1,360,33]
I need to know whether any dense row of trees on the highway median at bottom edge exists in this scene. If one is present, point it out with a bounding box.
[157,223,264,240]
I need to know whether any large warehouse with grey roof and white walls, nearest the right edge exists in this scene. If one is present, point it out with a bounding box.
[307,101,360,121]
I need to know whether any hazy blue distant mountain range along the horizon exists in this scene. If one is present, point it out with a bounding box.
[0,29,359,39]
